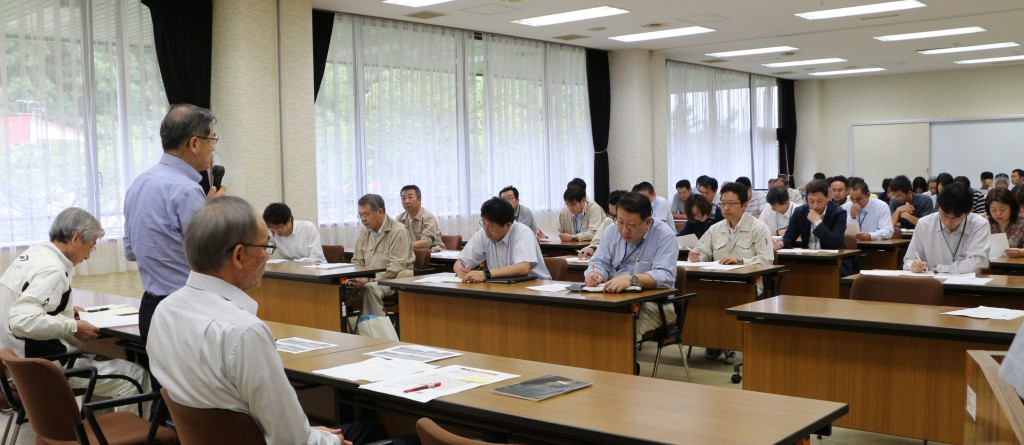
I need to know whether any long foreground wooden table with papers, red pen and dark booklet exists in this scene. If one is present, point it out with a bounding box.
[285,341,847,444]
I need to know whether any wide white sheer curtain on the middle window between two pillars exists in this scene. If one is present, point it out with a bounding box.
[315,14,593,246]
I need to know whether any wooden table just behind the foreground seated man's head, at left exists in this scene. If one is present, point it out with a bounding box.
[247,261,385,332]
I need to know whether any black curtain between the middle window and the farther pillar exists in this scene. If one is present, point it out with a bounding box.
[587,49,611,209]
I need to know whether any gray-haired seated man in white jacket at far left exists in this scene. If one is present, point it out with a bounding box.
[0,207,150,414]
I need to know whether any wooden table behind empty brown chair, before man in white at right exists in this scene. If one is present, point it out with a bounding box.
[840,274,1024,309]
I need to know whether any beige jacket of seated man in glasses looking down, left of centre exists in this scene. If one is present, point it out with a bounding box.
[352,215,416,280]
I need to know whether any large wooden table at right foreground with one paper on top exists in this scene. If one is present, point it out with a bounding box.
[728,294,1021,443]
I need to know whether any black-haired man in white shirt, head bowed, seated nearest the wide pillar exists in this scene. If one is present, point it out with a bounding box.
[263,203,327,263]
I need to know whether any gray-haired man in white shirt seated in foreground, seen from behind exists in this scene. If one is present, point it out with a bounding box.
[146,196,405,445]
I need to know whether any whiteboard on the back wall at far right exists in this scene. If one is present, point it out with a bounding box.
[930,119,1024,184]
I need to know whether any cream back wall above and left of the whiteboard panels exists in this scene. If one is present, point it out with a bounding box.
[796,64,1024,187]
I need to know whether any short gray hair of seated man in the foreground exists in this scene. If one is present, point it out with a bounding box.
[184,196,259,272]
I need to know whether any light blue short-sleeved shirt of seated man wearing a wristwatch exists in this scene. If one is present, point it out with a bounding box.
[584,218,679,288]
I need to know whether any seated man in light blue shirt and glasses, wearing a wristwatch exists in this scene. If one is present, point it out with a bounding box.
[584,192,679,340]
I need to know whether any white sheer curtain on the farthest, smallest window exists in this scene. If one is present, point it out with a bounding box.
[668,60,778,189]
